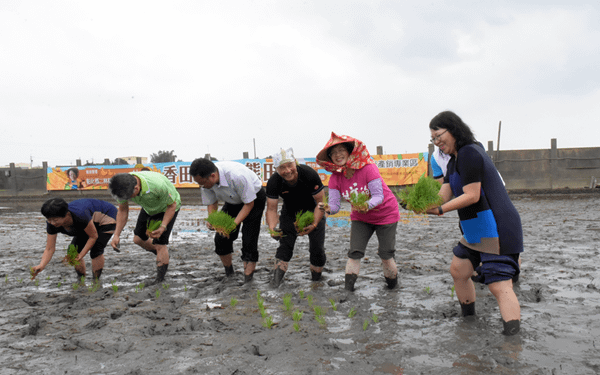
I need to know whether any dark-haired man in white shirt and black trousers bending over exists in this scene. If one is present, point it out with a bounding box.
[190,159,266,282]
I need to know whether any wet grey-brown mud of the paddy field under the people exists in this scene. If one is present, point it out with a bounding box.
[0,195,600,375]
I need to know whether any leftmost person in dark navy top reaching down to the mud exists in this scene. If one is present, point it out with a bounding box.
[31,198,117,282]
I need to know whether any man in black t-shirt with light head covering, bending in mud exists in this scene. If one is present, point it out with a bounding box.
[266,148,327,287]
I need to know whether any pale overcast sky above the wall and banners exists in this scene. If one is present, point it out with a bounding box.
[0,0,600,166]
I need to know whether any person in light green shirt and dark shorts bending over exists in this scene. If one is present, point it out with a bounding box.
[108,172,181,285]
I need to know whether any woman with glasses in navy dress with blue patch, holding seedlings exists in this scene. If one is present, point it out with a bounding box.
[427,111,523,335]
